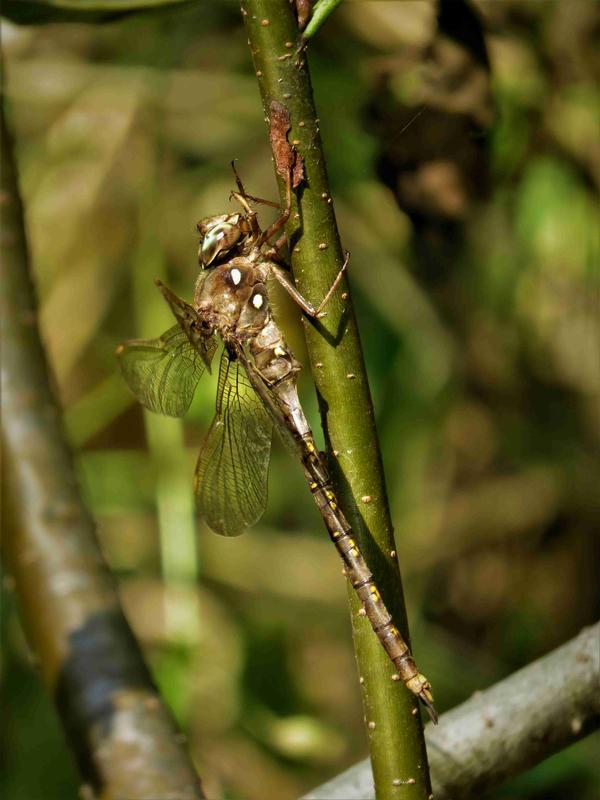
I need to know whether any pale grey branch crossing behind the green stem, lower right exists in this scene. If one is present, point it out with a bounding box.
[303,622,600,800]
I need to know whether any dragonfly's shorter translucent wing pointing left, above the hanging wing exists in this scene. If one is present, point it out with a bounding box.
[117,325,217,417]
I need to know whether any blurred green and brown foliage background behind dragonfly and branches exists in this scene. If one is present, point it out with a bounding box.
[0,0,600,800]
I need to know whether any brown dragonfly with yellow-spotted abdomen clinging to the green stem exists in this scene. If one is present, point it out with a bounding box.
[117,165,437,723]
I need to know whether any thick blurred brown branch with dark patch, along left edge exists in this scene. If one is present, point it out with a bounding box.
[0,76,204,800]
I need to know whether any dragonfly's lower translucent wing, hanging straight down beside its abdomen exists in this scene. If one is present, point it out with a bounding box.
[194,350,273,536]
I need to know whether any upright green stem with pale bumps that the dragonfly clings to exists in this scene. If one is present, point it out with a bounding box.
[242,0,431,800]
